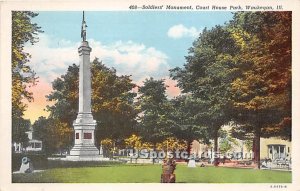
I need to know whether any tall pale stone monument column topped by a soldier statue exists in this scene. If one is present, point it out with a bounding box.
[67,12,101,161]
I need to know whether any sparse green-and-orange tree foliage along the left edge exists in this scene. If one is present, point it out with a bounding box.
[11,11,42,142]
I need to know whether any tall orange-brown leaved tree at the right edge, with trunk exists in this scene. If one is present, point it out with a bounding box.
[230,12,291,168]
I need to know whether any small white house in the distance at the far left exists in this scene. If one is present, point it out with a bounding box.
[13,127,43,153]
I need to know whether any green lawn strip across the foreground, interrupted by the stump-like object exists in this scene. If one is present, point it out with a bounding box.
[12,165,292,183]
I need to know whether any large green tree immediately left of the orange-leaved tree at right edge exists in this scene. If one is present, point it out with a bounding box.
[170,26,238,165]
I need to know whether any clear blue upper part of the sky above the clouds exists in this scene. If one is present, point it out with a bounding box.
[33,11,232,67]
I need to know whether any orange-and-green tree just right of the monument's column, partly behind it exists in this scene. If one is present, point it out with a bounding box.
[92,59,138,144]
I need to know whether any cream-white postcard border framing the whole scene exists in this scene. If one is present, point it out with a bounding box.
[0,0,300,191]
